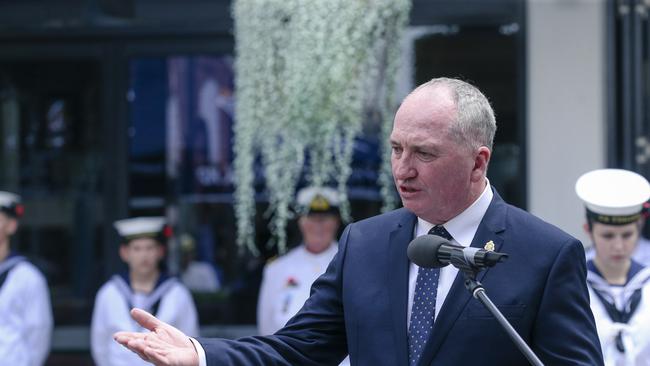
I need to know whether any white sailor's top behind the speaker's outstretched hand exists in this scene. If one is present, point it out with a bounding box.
[90,275,199,366]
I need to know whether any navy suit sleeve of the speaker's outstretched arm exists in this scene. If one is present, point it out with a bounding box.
[197,226,350,366]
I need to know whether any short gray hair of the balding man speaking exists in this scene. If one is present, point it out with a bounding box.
[413,78,497,150]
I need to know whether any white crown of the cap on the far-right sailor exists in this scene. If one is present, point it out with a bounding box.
[576,169,650,216]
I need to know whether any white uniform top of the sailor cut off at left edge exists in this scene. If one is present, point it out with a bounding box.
[0,256,53,366]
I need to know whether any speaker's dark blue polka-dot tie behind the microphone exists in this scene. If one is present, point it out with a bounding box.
[409,225,451,366]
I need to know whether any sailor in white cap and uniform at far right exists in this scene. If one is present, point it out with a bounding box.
[576,169,650,366]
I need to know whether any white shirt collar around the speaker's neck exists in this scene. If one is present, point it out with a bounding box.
[415,178,494,247]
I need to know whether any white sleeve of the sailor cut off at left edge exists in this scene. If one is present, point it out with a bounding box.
[23,272,53,366]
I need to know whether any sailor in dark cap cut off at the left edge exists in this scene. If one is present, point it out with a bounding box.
[0,192,53,366]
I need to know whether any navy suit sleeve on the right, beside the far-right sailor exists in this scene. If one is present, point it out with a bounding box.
[532,239,603,365]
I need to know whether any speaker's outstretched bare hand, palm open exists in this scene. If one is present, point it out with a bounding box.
[113,309,199,366]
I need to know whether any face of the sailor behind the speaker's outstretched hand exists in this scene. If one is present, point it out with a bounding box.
[120,238,164,275]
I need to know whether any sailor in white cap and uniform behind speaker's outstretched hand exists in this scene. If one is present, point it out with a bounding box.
[90,217,199,366]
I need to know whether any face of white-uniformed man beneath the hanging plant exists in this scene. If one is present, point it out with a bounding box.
[298,213,339,253]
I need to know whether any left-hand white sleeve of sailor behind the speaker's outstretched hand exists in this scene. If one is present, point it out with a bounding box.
[90,288,114,366]
